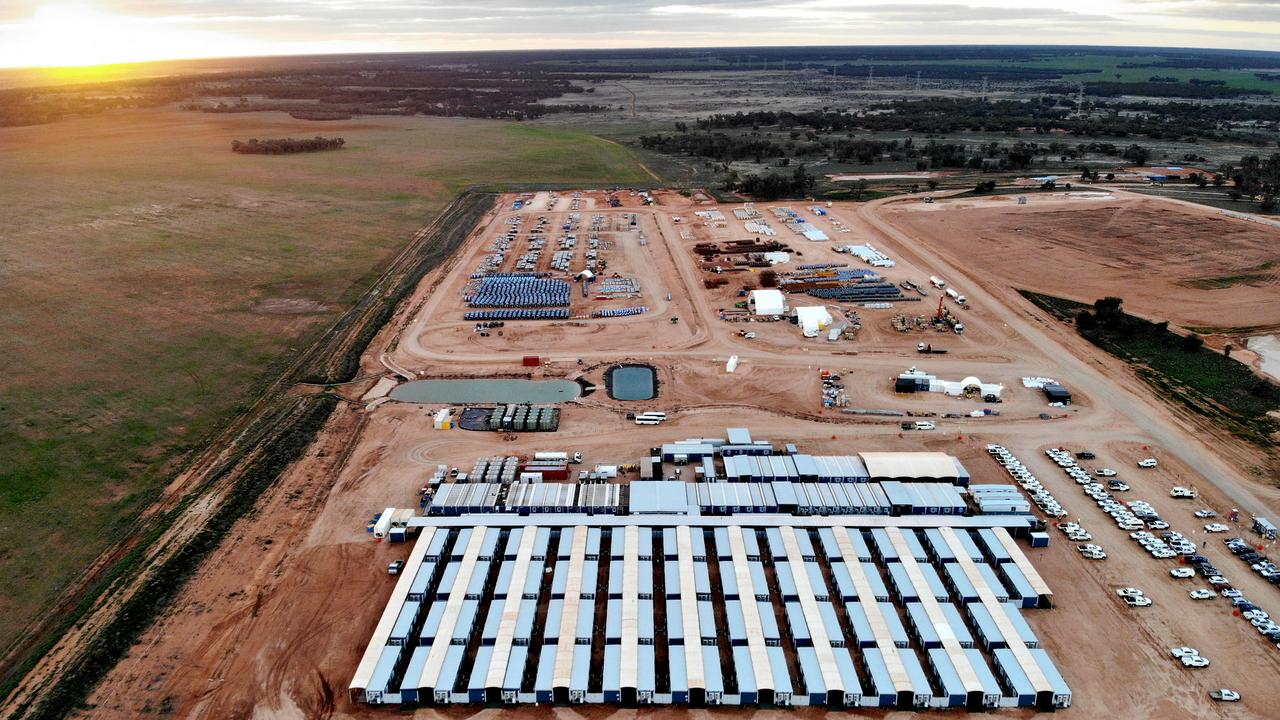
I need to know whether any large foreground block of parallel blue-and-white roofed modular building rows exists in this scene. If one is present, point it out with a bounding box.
[349,512,1071,710]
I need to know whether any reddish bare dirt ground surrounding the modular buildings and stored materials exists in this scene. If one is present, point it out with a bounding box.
[82,192,1280,720]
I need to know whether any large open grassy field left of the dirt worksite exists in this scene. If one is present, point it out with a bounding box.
[0,110,653,648]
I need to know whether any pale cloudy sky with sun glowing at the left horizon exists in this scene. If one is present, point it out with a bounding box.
[0,0,1280,68]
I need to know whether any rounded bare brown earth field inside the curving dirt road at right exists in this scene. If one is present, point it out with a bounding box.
[891,191,1280,328]
